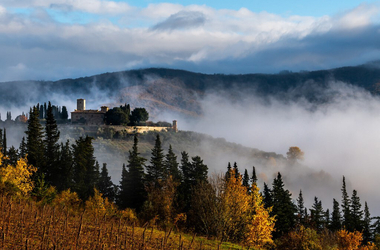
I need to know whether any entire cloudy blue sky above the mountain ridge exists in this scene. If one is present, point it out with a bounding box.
[0,0,380,81]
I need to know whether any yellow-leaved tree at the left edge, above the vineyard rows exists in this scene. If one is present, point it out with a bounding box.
[0,151,37,195]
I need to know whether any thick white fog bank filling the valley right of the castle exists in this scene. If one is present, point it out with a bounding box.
[179,81,380,215]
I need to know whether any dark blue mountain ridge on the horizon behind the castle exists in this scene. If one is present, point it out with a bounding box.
[0,63,380,116]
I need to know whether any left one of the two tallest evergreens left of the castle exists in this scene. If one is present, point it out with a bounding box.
[25,105,45,174]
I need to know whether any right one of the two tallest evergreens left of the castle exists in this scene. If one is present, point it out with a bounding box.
[41,102,61,186]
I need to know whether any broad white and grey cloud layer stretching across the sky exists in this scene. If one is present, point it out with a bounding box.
[0,0,378,80]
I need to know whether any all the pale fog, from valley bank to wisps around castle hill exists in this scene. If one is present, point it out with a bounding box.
[0,73,380,215]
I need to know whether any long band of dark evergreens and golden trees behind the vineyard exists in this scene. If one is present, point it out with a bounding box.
[0,102,380,249]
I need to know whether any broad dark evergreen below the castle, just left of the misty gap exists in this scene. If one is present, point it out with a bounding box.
[72,136,99,200]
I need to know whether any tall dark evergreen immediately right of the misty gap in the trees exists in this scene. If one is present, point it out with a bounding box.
[119,134,146,211]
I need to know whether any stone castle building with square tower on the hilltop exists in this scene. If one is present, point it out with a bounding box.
[71,99,108,125]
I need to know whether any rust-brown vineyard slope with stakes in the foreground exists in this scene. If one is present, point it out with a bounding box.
[0,196,243,250]
